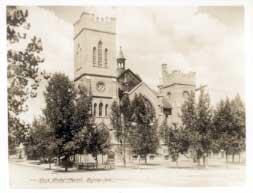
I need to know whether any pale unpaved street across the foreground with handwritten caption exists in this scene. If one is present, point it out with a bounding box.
[9,158,245,188]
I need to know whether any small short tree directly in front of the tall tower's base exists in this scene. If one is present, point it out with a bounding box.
[86,123,110,167]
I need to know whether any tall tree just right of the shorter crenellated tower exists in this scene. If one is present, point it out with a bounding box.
[181,89,213,166]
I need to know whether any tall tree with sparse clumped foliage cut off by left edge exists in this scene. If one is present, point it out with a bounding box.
[6,6,44,152]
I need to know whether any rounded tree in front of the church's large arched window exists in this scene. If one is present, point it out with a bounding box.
[129,94,159,163]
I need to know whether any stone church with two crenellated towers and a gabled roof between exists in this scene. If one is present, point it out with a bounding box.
[74,12,195,157]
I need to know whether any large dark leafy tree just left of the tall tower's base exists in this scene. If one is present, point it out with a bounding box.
[44,76,93,171]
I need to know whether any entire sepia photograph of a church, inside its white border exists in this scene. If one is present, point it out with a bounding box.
[6,5,246,188]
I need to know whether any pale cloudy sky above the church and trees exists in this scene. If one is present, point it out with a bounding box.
[16,6,245,121]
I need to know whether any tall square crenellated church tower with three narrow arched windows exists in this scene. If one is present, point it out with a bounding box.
[74,12,118,125]
